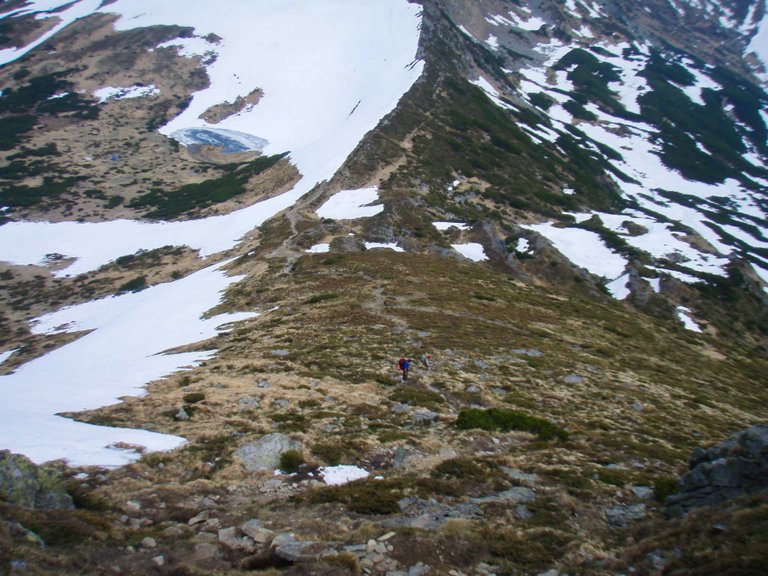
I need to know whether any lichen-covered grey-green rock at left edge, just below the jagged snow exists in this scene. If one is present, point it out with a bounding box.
[0,450,74,510]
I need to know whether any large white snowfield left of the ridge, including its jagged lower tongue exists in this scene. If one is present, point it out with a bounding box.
[0,0,423,466]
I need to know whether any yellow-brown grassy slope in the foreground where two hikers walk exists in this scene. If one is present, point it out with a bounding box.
[25,250,768,573]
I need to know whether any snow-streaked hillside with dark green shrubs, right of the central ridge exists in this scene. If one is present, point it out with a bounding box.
[460,1,768,298]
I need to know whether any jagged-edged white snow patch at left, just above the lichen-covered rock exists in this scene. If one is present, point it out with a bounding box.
[0,263,257,466]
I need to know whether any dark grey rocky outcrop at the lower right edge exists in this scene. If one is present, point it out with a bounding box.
[665,424,768,517]
